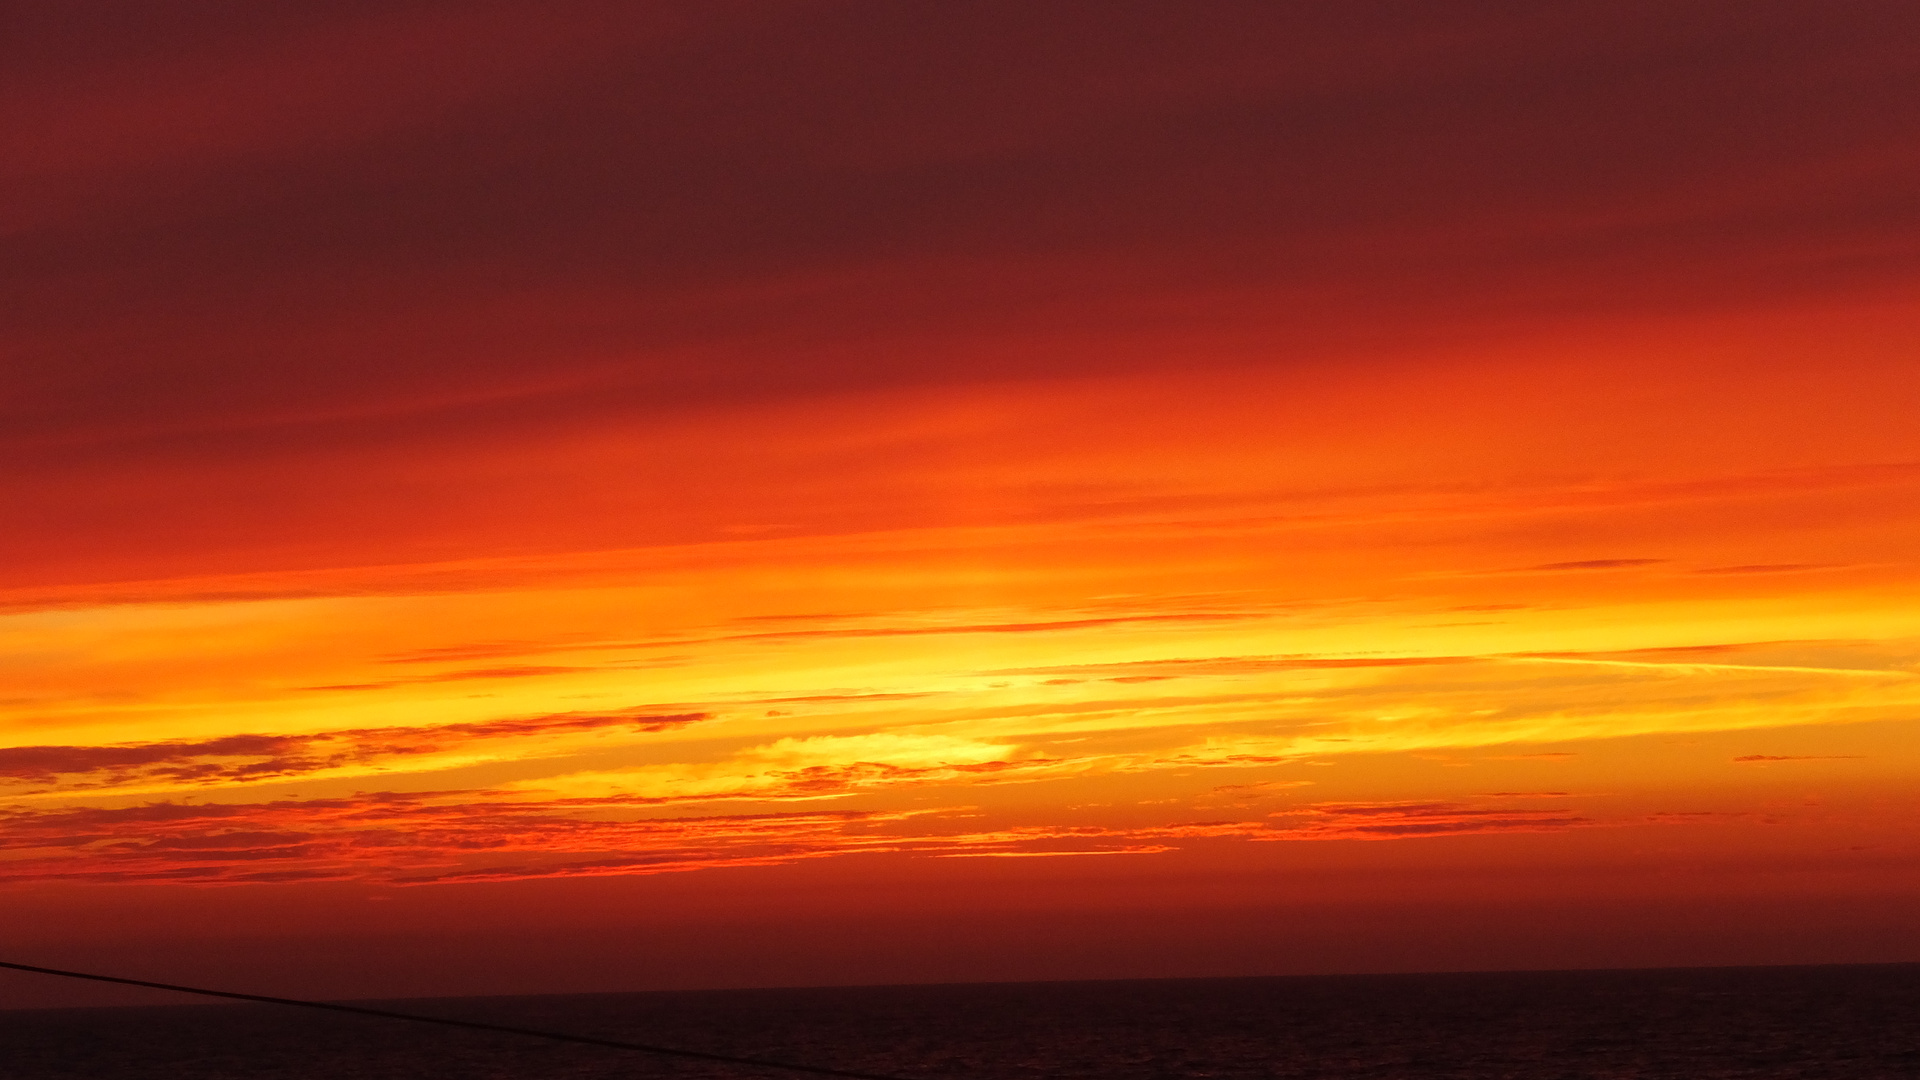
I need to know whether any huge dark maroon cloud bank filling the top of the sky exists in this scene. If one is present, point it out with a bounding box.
[0,0,1920,580]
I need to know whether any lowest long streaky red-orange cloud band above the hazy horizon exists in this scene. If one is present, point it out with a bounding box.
[0,792,1597,884]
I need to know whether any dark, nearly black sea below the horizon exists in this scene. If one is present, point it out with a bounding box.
[0,965,1920,1080]
